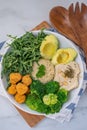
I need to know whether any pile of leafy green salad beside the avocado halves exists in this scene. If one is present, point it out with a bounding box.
[2,31,46,76]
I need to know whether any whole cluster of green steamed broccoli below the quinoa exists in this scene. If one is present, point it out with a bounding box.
[25,80,68,114]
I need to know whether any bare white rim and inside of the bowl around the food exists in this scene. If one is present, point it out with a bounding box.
[0,31,84,115]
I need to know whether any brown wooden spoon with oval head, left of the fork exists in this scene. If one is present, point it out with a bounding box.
[49,6,79,44]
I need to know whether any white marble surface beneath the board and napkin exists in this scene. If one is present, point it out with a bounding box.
[0,0,87,130]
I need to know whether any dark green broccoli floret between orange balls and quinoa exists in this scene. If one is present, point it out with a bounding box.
[30,80,46,98]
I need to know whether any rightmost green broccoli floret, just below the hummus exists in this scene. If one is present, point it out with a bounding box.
[57,88,68,104]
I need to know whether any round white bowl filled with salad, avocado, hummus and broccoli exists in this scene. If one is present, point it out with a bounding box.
[0,30,84,115]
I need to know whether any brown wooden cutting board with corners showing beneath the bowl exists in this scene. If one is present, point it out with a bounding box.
[16,21,51,127]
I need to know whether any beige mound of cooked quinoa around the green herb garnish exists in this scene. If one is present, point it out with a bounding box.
[32,59,54,83]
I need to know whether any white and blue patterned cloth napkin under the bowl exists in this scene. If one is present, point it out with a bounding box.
[0,28,87,123]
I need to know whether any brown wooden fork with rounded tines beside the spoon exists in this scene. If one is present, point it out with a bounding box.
[69,2,87,61]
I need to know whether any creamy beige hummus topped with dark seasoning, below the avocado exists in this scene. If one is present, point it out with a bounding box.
[54,61,80,91]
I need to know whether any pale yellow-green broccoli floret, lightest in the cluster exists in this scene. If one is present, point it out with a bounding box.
[43,93,57,105]
